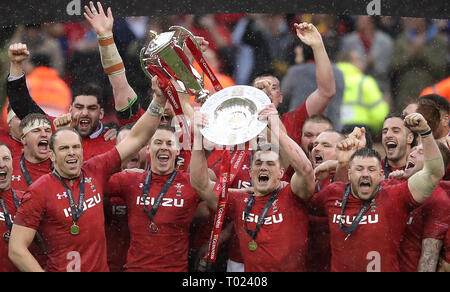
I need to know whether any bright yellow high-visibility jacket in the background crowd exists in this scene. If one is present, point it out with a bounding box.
[336,62,389,133]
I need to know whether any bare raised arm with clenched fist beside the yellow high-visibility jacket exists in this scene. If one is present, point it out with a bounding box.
[295,23,336,115]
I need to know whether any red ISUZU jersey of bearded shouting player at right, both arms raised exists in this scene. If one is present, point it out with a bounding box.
[310,182,419,272]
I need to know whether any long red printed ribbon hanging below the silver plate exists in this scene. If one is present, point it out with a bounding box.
[205,148,248,263]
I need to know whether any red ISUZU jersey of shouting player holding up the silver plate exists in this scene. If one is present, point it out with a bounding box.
[227,185,308,272]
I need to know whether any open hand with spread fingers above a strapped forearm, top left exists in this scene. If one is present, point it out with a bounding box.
[83,1,114,36]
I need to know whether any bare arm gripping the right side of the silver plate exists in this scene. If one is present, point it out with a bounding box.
[259,104,315,200]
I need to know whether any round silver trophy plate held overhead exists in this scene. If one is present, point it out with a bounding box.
[200,85,271,145]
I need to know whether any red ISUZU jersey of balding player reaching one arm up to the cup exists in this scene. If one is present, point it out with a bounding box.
[14,148,121,272]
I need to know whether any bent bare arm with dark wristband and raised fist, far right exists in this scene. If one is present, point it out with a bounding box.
[405,113,445,203]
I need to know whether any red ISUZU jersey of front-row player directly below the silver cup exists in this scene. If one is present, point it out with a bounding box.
[106,170,200,272]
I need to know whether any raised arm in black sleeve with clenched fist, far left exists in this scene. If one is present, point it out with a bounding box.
[6,43,45,120]
